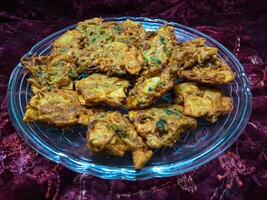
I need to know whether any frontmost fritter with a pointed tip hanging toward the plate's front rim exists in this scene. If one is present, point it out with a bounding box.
[86,112,153,169]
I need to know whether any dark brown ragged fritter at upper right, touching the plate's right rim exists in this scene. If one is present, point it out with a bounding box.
[170,38,235,85]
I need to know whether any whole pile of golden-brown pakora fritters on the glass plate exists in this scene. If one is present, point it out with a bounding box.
[22,18,235,169]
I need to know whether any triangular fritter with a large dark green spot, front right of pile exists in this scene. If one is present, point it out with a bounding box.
[128,105,197,149]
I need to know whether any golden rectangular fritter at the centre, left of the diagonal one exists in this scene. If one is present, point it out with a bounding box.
[75,73,129,107]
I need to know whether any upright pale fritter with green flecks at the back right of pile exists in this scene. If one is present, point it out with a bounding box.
[142,26,176,73]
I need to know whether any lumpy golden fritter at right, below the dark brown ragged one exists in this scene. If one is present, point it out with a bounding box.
[174,82,233,123]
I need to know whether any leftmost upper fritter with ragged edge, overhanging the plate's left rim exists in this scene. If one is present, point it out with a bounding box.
[21,55,78,94]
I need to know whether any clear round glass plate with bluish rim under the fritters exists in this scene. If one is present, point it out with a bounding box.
[8,17,252,180]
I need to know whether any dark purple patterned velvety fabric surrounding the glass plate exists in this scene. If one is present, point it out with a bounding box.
[0,0,267,200]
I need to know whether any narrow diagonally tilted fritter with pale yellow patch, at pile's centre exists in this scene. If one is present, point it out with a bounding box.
[126,66,175,109]
